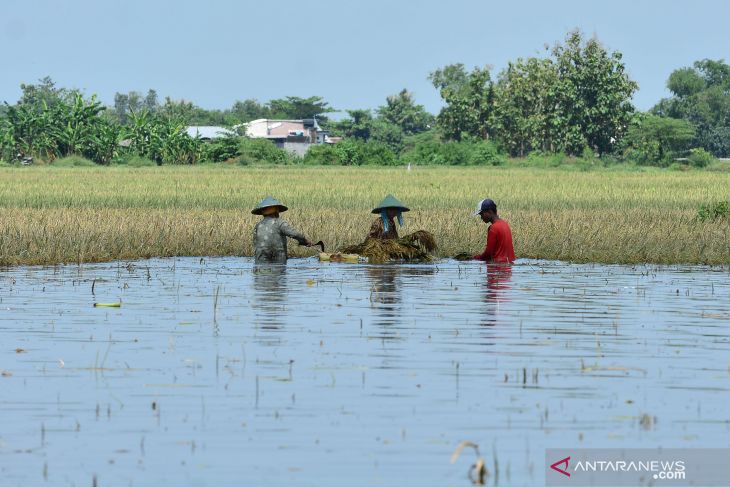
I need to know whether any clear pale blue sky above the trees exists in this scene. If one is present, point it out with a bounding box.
[0,0,730,112]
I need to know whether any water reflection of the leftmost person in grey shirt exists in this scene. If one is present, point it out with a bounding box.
[251,264,288,330]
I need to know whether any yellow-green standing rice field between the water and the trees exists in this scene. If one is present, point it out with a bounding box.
[0,166,730,265]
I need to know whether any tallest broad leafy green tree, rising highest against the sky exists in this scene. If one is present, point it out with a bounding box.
[494,31,637,156]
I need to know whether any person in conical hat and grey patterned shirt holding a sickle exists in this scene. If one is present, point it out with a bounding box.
[251,196,312,264]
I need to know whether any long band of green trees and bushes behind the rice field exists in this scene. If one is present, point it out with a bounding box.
[0,31,730,166]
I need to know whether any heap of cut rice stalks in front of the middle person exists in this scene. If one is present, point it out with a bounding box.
[341,230,436,263]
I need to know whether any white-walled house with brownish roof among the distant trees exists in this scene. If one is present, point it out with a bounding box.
[245,118,333,156]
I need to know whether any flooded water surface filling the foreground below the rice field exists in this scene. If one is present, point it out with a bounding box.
[0,258,730,486]
